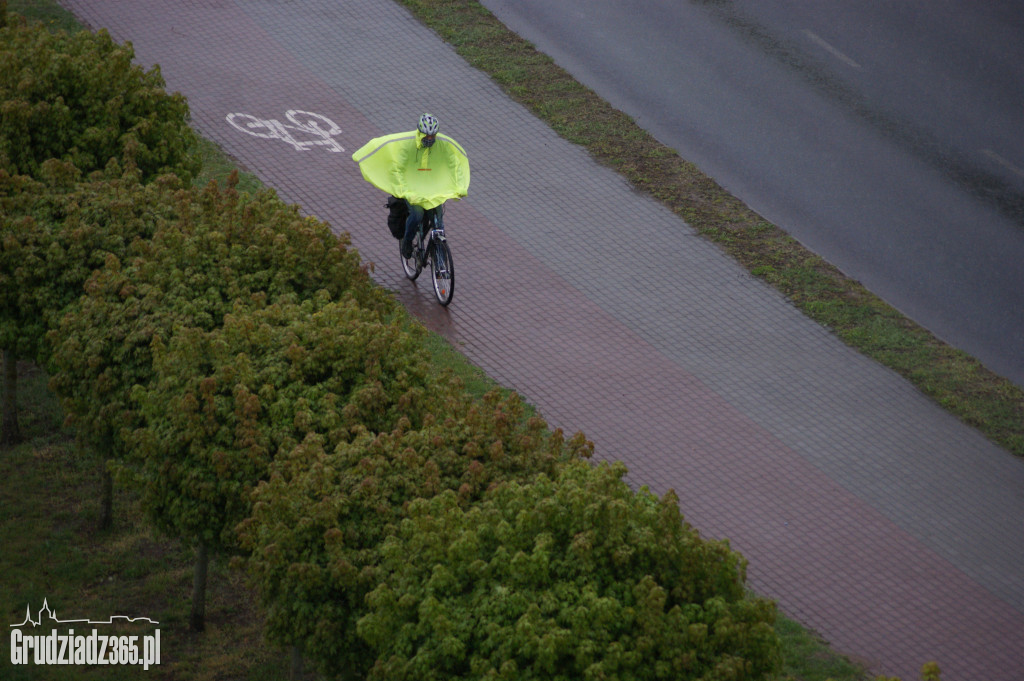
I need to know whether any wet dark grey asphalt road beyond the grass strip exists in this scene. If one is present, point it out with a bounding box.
[482,0,1024,386]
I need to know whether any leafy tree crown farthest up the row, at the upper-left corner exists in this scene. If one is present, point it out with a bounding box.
[0,22,200,183]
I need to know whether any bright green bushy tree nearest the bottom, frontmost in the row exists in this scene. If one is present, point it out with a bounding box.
[358,462,781,681]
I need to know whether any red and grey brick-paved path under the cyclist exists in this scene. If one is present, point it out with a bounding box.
[60,0,1024,681]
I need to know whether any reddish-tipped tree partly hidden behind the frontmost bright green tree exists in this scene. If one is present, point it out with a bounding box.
[240,390,593,678]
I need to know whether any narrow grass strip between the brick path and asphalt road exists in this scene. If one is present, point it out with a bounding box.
[398,0,1024,456]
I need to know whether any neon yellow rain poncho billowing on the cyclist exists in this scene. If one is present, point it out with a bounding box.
[352,130,469,210]
